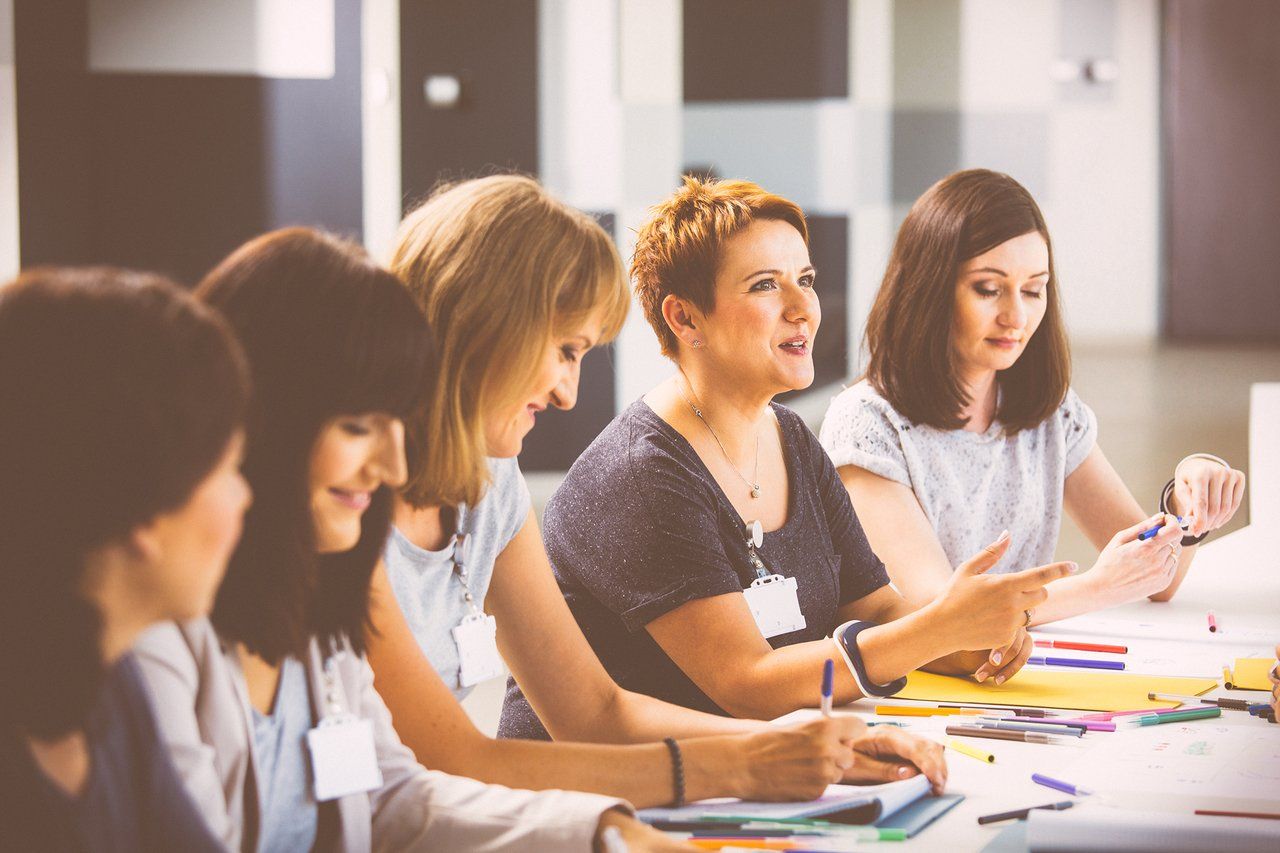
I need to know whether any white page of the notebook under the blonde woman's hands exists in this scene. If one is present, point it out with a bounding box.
[639,775,929,824]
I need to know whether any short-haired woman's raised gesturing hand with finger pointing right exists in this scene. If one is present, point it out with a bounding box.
[928,530,1076,651]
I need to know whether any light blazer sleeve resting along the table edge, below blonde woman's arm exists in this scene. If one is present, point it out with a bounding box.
[360,648,634,853]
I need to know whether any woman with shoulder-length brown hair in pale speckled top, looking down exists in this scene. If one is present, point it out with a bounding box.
[822,169,1244,624]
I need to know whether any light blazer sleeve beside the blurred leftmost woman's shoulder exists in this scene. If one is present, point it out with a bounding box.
[133,622,243,850]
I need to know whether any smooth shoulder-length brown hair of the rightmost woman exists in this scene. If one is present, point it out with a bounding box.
[867,169,1071,433]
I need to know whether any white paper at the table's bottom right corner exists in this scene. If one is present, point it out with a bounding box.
[1027,808,1280,853]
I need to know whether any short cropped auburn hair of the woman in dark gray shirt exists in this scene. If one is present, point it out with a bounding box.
[631,175,809,359]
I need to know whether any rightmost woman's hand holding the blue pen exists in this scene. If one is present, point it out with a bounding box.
[1085,512,1183,603]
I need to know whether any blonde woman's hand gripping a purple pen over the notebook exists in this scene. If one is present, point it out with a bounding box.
[732,713,867,802]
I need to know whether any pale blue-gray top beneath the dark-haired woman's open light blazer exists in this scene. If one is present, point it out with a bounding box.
[253,657,320,853]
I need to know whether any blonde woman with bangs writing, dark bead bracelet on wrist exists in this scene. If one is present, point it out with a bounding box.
[369,175,946,806]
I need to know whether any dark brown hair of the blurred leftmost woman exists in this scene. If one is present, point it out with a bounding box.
[0,268,248,738]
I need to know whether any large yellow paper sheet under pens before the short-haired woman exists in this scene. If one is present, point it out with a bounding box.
[893,669,1217,711]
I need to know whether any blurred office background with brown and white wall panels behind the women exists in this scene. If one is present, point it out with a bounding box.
[0,0,1280,671]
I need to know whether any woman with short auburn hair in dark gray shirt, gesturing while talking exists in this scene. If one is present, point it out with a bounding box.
[504,178,1069,733]
